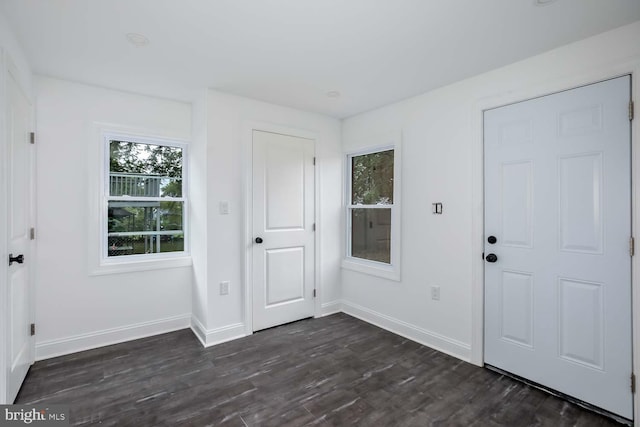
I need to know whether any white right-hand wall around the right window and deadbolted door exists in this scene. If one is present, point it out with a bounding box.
[342,22,640,363]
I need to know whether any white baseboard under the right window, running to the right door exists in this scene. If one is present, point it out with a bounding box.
[341,301,471,362]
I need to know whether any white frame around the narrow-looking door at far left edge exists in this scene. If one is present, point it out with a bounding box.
[0,47,36,404]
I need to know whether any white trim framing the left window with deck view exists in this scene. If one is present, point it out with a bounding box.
[88,124,192,276]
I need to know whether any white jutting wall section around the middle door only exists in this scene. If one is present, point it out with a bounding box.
[196,91,342,344]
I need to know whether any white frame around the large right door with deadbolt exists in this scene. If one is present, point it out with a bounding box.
[470,61,640,426]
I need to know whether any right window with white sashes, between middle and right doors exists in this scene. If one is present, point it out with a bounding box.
[343,147,399,279]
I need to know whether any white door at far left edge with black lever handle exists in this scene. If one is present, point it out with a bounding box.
[2,65,34,403]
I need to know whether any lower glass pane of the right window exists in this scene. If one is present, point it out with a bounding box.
[351,208,391,264]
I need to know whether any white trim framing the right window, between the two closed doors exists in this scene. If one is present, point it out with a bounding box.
[342,142,402,282]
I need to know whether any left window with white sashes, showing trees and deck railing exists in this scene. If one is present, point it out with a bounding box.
[102,135,186,259]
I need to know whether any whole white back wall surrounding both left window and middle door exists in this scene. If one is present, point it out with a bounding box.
[30,77,342,359]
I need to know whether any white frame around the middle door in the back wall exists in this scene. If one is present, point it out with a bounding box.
[242,121,322,335]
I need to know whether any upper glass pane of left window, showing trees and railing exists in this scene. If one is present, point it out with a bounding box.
[109,141,182,197]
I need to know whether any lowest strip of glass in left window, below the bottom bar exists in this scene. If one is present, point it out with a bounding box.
[107,234,184,257]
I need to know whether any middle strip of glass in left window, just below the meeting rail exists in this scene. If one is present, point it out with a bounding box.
[108,201,183,234]
